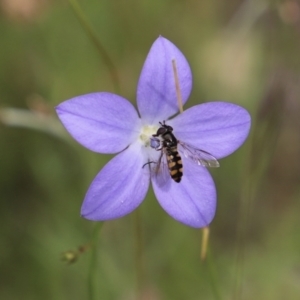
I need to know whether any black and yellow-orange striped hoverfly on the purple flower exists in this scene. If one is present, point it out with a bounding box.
[149,121,219,182]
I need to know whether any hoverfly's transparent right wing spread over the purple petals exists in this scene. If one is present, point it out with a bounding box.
[178,141,220,168]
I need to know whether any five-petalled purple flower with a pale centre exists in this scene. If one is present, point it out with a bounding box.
[56,37,251,228]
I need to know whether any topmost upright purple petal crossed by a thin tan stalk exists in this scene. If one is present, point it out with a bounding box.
[137,37,192,124]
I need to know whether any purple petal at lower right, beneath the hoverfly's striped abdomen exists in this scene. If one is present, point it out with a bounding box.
[152,157,217,228]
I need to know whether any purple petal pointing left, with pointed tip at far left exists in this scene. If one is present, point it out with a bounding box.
[56,93,141,153]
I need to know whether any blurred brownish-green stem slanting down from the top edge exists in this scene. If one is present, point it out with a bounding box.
[68,0,120,92]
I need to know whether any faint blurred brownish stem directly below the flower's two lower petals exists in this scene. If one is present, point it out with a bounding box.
[133,209,145,299]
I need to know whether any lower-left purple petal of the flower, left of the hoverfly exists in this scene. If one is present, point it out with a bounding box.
[81,143,150,221]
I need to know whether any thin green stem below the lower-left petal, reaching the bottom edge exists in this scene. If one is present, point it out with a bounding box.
[88,222,104,300]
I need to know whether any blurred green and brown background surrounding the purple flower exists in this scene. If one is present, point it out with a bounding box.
[0,0,300,300]
